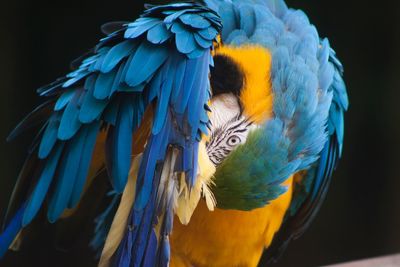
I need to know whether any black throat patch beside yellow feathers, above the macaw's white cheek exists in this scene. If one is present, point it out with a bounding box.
[210,55,245,96]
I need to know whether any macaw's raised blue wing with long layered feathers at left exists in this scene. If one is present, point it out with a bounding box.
[0,3,221,265]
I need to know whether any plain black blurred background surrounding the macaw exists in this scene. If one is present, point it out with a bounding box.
[0,0,400,267]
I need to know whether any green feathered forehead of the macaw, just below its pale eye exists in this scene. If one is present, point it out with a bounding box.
[212,129,287,210]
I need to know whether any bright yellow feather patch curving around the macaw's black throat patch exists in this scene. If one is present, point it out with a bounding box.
[214,45,273,124]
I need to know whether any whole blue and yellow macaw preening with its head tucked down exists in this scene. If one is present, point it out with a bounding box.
[0,0,348,267]
